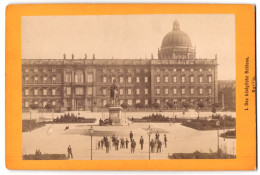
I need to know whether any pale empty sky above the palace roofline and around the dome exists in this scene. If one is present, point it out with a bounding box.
[21,14,236,80]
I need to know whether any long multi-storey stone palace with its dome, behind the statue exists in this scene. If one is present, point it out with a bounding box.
[22,21,218,111]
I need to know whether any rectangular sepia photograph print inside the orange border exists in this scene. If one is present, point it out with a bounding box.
[21,14,236,160]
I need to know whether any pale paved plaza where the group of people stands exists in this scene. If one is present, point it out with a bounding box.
[23,112,236,160]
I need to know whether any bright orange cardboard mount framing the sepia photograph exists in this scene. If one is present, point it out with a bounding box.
[5,4,256,170]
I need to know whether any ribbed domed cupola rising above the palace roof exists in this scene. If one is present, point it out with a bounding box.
[158,20,195,59]
